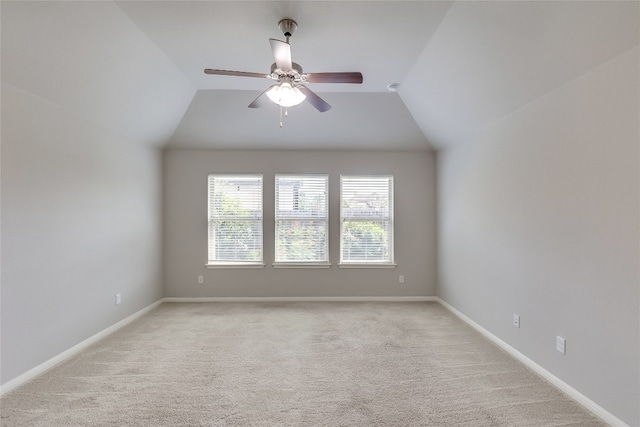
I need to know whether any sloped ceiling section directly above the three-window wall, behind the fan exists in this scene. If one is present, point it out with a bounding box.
[170,90,429,150]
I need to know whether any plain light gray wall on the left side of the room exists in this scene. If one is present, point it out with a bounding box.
[0,83,162,384]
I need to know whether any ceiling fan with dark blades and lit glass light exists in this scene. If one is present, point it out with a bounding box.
[204,19,362,127]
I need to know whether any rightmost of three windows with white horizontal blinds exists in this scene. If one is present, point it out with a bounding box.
[340,175,393,265]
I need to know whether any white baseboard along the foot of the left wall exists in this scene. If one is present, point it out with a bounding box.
[0,299,162,396]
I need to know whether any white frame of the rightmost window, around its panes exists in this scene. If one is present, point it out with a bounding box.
[338,174,397,268]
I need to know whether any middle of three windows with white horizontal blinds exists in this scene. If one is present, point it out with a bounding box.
[275,175,329,265]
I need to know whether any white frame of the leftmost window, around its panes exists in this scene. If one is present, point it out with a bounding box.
[206,173,264,268]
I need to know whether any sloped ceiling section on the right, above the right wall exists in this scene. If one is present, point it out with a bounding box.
[399,1,640,148]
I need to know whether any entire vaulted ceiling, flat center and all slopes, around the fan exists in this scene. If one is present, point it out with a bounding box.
[1,1,640,150]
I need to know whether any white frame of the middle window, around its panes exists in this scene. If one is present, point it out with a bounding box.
[272,173,331,268]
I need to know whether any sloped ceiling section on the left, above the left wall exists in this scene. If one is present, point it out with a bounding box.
[0,1,195,145]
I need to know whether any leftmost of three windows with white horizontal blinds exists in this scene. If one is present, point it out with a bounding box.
[208,175,263,265]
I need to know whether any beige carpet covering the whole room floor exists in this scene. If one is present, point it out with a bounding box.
[0,303,604,427]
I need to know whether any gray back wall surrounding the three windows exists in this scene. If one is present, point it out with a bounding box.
[164,150,436,297]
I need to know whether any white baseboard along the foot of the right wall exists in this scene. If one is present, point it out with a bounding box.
[436,297,629,427]
